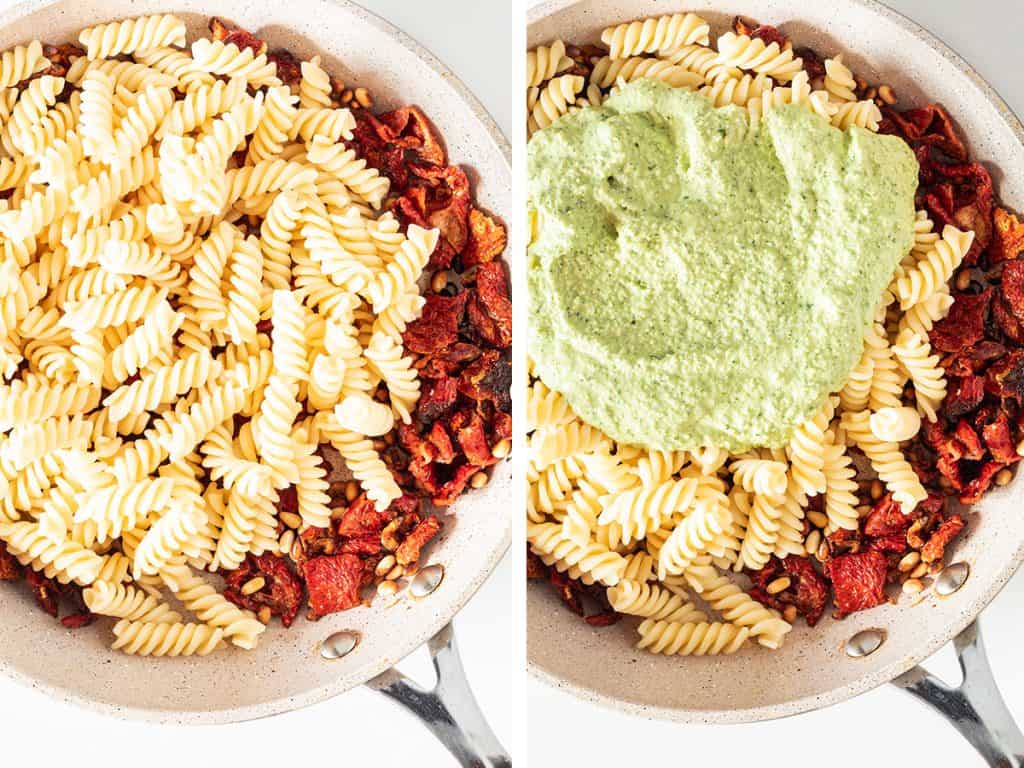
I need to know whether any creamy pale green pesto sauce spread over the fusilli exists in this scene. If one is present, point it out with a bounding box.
[527,80,918,451]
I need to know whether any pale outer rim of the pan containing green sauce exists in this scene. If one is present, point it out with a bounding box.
[526,0,1024,725]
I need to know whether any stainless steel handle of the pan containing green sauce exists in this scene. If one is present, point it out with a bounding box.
[893,621,1024,768]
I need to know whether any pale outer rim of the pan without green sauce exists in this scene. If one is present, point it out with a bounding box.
[0,0,513,725]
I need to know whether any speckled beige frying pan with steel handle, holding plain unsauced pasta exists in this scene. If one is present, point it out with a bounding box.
[0,0,513,766]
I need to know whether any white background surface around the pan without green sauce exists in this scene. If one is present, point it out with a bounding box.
[0,0,524,768]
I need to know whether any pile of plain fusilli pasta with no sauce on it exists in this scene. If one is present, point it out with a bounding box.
[0,14,438,655]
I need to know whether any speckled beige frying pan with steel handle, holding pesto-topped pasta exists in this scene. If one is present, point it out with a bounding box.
[527,0,1024,766]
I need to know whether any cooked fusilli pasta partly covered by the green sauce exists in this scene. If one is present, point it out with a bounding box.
[526,13,974,655]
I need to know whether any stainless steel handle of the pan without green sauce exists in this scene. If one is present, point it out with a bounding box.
[367,624,512,768]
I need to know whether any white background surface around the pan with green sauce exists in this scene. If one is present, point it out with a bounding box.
[527,0,1024,768]
